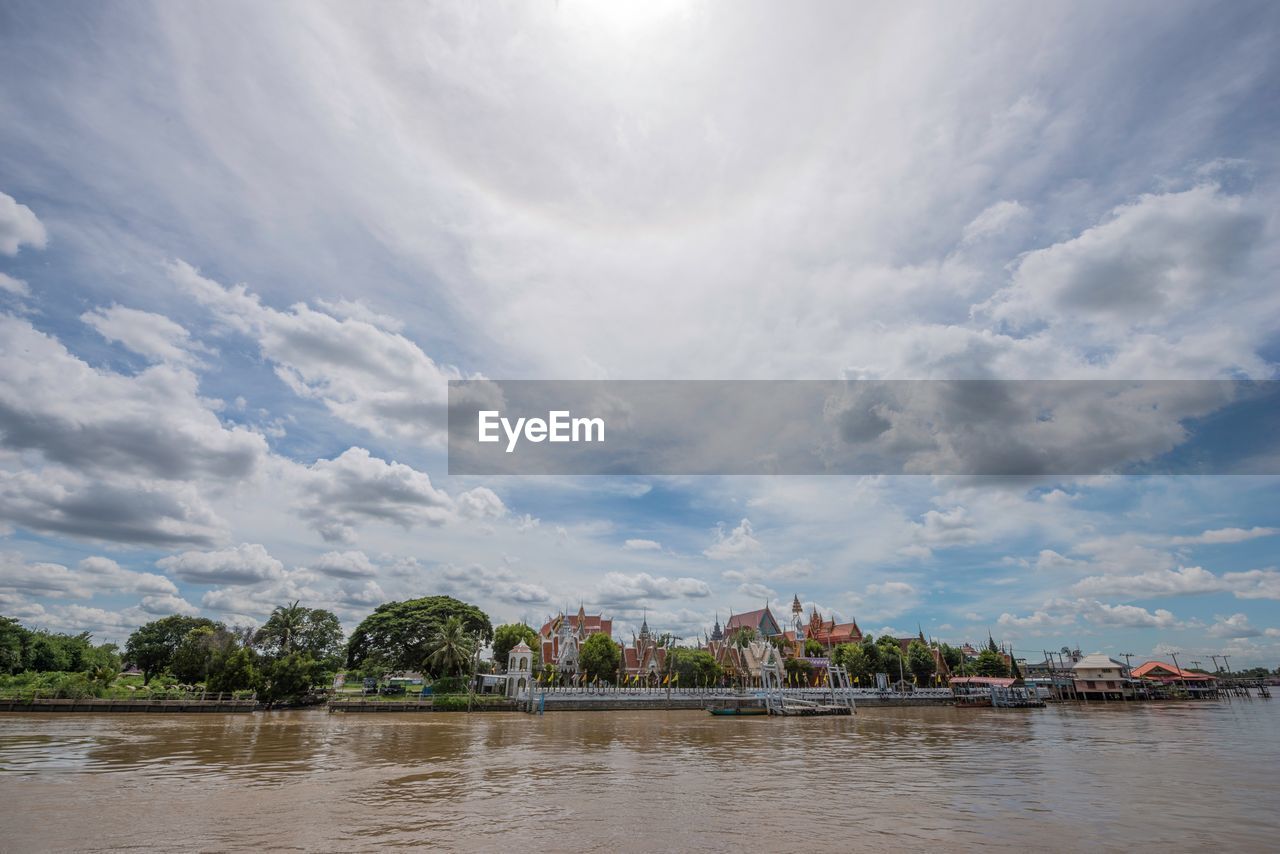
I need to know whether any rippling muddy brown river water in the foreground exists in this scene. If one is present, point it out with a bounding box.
[0,699,1280,854]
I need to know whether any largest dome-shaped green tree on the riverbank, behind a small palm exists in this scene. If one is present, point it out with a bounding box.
[347,597,493,675]
